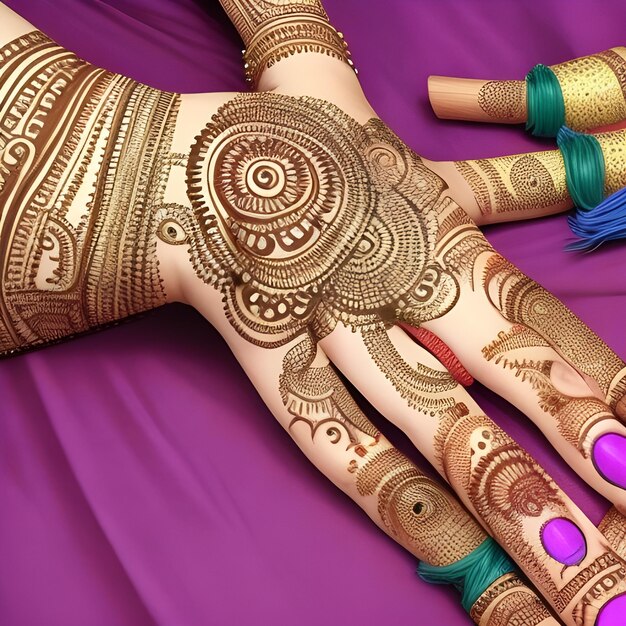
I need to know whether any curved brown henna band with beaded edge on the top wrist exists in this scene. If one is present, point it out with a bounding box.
[243,13,357,85]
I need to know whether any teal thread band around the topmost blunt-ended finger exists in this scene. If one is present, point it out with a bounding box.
[526,63,565,137]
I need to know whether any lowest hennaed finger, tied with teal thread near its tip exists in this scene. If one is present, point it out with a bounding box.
[218,324,556,626]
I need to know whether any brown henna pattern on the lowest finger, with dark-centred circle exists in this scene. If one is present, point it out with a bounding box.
[279,337,547,626]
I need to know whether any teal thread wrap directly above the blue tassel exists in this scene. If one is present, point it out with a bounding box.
[556,126,606,211]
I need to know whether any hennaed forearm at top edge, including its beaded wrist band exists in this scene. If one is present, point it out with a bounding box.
[221,0,352,84]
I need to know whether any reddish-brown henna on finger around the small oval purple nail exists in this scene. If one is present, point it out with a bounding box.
[437,405,626,624]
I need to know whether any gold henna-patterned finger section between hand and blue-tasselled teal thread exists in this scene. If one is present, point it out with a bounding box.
[454,150,569,215]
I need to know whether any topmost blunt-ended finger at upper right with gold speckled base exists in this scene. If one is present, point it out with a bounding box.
[428,47,626,134]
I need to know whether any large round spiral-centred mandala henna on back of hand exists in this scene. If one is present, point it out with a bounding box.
[187,93,370,292]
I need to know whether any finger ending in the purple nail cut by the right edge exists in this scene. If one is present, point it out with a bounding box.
[426,278,626,511]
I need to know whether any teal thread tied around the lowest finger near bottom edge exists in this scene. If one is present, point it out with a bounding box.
[417,537,516,613]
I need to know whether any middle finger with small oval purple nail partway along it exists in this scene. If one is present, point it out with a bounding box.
[322,325,626,624]
